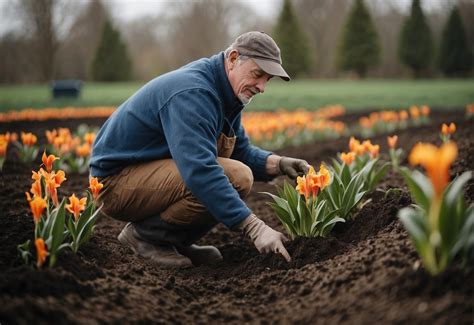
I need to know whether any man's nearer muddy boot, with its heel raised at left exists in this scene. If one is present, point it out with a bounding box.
[117,222,193,268]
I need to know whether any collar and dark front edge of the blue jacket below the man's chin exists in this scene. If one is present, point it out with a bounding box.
[210,52,244,117]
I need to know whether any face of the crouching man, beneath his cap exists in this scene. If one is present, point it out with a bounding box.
[227,52,273,105]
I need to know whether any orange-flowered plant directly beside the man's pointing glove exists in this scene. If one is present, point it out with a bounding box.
[264,165,344,238]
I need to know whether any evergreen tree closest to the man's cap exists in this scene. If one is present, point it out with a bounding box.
[274,0,311,78]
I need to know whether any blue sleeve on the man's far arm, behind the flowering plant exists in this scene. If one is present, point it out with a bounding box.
[231,116,275,181]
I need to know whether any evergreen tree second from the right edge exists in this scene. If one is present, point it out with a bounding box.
[398,0,433,78]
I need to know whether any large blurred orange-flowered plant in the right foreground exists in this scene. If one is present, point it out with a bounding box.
[398,142,474,275]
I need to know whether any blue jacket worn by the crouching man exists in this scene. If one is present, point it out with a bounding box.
[90,52,271,227]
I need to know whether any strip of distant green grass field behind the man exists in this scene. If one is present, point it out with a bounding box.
[0,79,474,111]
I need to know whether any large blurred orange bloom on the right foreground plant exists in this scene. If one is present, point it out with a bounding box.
[408,142,458,197]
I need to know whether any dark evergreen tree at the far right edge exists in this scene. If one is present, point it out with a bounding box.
[439,7,473,76]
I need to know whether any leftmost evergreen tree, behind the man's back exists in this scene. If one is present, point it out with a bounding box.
[92,20,131,81]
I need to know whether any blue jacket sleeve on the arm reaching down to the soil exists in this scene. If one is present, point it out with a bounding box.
[159,89,251,228]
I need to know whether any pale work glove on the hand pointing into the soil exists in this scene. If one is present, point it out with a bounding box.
[237,213,291,262]
